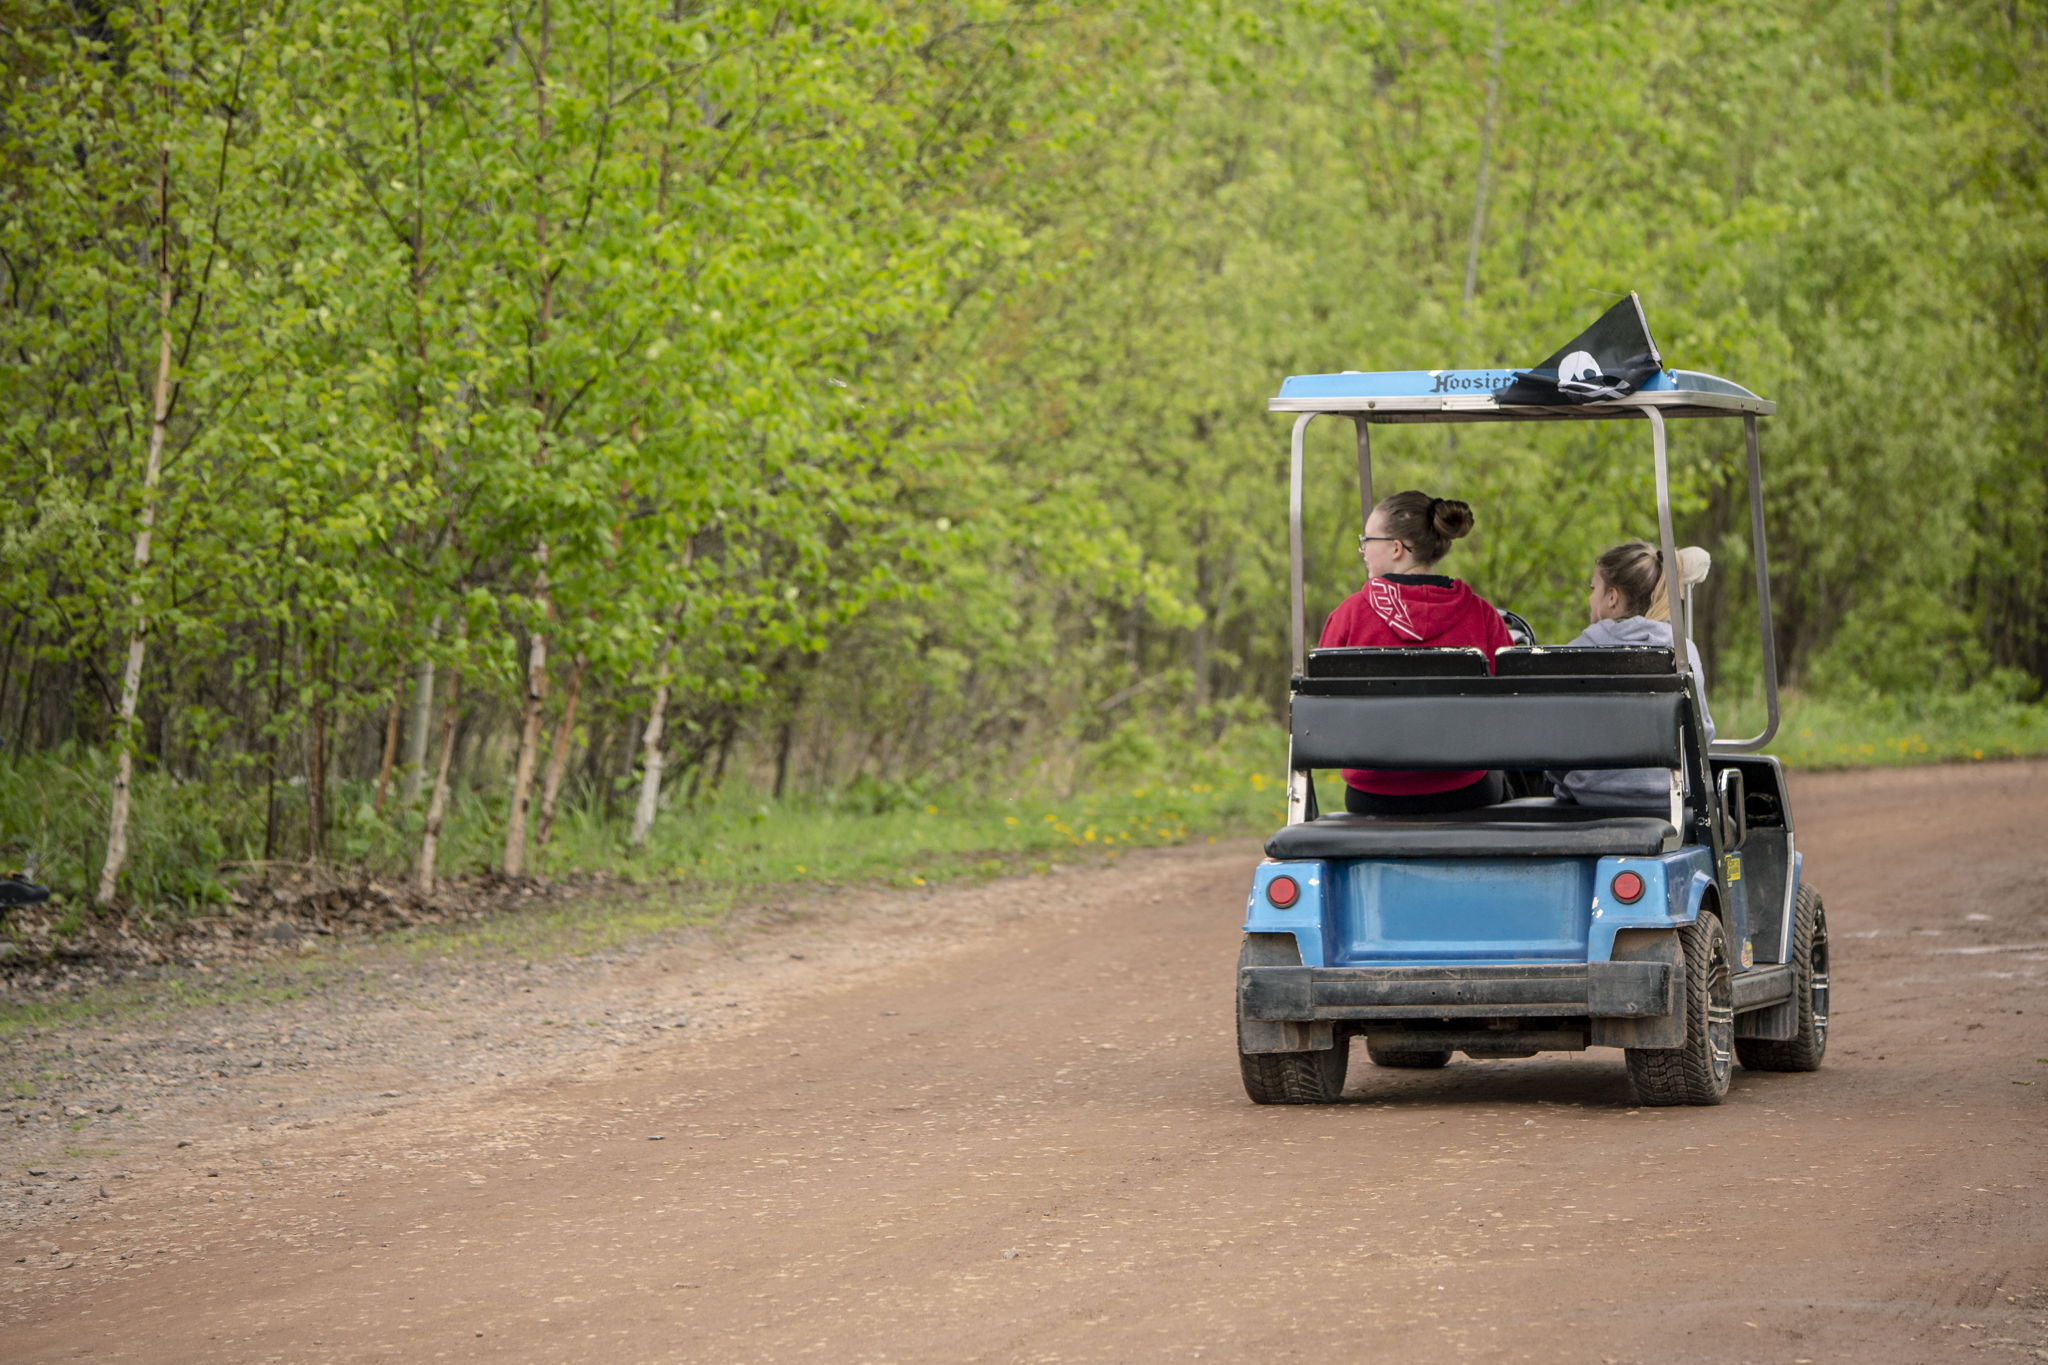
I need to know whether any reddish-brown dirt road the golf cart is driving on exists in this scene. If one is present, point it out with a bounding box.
[0,763,2048,1365]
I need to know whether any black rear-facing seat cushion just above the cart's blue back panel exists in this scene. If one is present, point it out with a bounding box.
[1266,796,1677,857]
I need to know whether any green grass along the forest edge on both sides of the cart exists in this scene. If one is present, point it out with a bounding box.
[0,686,2048,970]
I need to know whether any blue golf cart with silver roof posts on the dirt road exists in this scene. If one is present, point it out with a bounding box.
[1237,358,1829,1105]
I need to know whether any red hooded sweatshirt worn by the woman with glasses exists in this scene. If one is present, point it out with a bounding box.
[1317,573,1513,796]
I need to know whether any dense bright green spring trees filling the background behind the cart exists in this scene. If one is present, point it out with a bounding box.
[0,0,2048,912]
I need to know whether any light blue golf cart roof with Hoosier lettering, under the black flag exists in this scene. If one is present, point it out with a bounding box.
[1268,368,1778,422]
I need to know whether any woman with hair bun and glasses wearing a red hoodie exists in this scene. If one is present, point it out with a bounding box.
[1319,489,1509,814]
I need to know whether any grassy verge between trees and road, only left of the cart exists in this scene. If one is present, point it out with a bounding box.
[0,724,1284,1038]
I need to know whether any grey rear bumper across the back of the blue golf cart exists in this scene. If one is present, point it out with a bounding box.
[1237,962,1675,1023]
